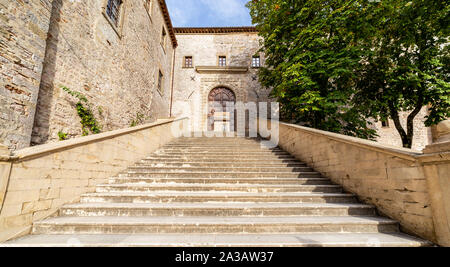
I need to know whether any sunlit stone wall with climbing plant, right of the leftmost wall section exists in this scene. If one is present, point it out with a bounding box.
[32,0,174,147]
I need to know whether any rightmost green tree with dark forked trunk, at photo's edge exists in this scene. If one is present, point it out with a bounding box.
[354,0,450,148]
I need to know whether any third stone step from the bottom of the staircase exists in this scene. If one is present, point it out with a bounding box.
[60,203,376,217]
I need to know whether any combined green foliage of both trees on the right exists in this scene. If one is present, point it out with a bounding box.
[247,0,448,146]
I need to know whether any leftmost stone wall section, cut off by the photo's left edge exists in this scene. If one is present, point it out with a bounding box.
[0,0,52,149]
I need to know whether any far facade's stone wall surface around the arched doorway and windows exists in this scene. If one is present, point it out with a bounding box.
[173,33,270,131]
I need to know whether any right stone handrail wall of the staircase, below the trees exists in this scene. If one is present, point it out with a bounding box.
[259,121,450,246]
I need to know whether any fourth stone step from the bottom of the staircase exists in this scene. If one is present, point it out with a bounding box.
[81,191,356,203]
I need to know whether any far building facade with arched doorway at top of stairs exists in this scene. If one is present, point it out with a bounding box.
[172,27,270,132]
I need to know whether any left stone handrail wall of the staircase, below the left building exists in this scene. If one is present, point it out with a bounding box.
[0,118,187,242]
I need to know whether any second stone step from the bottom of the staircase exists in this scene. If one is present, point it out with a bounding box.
[33,216,399,234]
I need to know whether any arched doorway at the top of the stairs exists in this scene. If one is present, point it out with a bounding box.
[208,87,236,132]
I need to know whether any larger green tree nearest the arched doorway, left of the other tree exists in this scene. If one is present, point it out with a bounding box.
[247,0,376,138]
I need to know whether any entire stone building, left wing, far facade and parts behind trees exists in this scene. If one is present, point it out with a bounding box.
[0,0,431,149]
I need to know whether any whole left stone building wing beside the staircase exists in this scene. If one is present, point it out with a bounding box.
[0,0,177,149]
